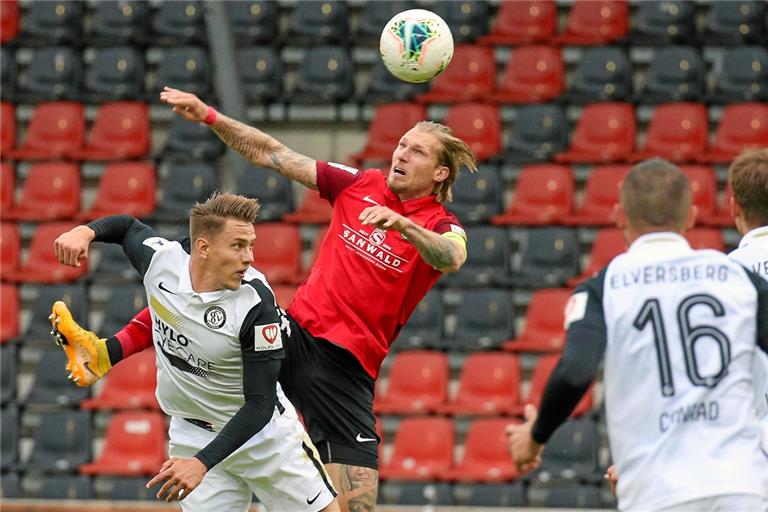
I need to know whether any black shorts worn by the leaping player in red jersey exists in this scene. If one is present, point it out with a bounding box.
[279,315,380,469]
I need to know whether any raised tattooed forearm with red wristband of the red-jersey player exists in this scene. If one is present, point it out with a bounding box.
[160,87,317,190]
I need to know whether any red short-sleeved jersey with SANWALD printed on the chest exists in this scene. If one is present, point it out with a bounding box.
[288,161,466,378]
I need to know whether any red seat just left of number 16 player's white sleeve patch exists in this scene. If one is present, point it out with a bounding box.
[502,288,571,352]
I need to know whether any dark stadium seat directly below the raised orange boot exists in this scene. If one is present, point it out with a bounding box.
[24,350,91,408]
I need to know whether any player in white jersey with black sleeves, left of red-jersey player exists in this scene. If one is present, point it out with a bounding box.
[53,194,339,512]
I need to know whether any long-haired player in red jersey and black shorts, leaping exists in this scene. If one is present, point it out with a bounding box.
[54,87,476,511]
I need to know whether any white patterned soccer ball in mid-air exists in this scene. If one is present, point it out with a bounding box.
[379,9,453,83]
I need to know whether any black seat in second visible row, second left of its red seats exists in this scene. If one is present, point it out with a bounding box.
[290,45,355,104]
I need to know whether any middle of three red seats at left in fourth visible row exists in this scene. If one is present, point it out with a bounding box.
[3,162,81,221]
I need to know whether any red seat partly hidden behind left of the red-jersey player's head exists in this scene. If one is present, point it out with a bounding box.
[349,103,427,167]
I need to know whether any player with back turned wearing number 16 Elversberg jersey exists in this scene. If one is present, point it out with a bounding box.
[508,160,768,510]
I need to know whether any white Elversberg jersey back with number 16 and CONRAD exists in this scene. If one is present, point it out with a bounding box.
[600,233,768,510]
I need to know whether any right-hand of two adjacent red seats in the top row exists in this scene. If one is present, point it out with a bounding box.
[556,0,629,45]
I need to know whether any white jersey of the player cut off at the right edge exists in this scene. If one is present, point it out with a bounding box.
[728,226,768,451]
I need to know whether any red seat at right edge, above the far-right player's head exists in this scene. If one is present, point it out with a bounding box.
[699,103,768,164]
